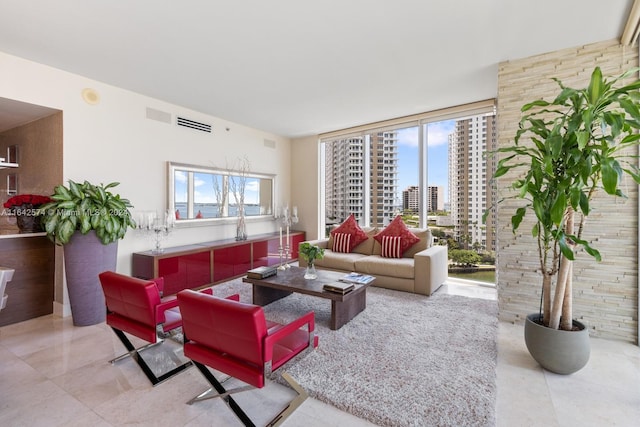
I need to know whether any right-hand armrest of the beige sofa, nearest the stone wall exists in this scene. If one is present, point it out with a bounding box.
[413,245,449,295]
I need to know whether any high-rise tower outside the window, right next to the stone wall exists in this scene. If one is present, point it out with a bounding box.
[449,115,497,251]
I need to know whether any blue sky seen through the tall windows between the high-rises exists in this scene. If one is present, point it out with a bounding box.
[398,120,455,202]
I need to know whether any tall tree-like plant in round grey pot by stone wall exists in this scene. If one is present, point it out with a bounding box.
[485,67,640,374]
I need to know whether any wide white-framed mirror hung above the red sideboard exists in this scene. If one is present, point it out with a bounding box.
[167,162,275,226]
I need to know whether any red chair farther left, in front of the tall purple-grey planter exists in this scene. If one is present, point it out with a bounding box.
[99,271,212,386]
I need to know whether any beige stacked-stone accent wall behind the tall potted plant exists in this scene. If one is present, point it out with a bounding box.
[496,41,638,343]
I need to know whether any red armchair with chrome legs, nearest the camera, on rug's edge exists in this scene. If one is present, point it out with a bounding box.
[178,290,318,426]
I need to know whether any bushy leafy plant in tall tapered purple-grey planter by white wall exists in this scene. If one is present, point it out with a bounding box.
[41,180,135,326]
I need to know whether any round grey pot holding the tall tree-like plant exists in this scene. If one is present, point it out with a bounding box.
[524,313,591,375]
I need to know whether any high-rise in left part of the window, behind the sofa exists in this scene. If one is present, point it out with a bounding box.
[325,131,400,226]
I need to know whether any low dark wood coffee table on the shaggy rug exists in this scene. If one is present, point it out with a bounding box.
[242,267,375,330]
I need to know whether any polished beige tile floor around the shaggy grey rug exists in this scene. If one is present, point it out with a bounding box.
[0,280,640,427]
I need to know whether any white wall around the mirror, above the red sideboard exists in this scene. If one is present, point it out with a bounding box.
[0,52,292,314]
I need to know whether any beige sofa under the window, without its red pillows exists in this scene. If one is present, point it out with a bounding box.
[298,227,448,295]
